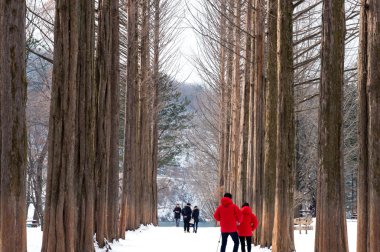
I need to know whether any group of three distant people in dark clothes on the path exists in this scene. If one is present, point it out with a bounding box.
[173,203,199,233]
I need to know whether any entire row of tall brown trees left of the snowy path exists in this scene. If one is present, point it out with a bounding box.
[0,0,182,251]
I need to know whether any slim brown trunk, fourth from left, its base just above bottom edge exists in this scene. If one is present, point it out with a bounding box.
[95,0,112,248]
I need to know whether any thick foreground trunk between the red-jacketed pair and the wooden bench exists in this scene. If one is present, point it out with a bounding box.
[272,0,295,252]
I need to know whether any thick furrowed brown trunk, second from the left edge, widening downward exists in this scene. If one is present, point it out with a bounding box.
[42,0,79,252]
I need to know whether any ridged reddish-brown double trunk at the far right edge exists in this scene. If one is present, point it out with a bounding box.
[357,0,380,252]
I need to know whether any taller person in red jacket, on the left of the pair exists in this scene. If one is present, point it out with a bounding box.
[214,193,243,252]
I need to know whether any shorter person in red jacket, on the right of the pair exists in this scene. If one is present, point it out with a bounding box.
[238,203,259,252]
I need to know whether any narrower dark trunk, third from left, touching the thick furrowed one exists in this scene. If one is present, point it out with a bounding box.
[75,0,98,251]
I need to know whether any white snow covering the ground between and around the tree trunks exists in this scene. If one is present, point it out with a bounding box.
[27,219,357,252]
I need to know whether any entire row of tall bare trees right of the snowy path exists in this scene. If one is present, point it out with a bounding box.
[194,0,379,251]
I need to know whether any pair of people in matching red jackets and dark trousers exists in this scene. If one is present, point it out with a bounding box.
[214,193,258,252]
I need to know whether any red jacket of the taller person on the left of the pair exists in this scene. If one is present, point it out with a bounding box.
[214,197,243,233]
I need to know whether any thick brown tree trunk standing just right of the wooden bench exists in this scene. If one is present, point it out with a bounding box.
[315,0,348,252]
